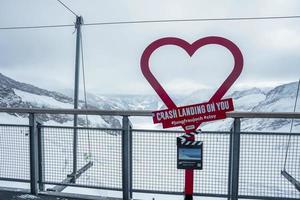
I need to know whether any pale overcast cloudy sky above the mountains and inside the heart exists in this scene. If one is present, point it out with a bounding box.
[0,0,300,97]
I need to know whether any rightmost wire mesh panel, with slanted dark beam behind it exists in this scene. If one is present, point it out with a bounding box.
[239,133,300,198]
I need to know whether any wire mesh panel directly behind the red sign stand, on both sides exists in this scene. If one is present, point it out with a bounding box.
[133,130,229,194]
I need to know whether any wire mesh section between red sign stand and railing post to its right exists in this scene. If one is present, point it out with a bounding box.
[194,132,230,195]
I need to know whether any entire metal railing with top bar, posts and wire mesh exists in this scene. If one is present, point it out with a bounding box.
[0,108,300,199]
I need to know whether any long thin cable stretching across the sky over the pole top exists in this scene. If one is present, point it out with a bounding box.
[0,13,300,30]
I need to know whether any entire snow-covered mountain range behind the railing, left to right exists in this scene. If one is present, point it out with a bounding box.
[0,74,300,131]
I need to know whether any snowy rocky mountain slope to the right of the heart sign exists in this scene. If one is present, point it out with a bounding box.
[191,82,300,132]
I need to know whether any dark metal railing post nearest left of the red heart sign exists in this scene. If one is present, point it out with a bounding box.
[122,116,132,200]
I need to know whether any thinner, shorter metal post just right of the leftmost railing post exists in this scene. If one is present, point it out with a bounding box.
[37,122,45,191]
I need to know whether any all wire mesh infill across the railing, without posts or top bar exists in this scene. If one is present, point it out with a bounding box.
[0,119,300,199]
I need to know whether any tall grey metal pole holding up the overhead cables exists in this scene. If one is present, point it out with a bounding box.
[72,16,83,183]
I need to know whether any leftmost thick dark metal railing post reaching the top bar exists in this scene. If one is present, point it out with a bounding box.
[29,113,39,195]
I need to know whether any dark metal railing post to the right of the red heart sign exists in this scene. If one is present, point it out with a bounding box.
[228,118,241,200]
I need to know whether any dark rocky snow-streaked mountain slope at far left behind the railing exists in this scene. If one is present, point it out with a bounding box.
[0,73,121,127]
